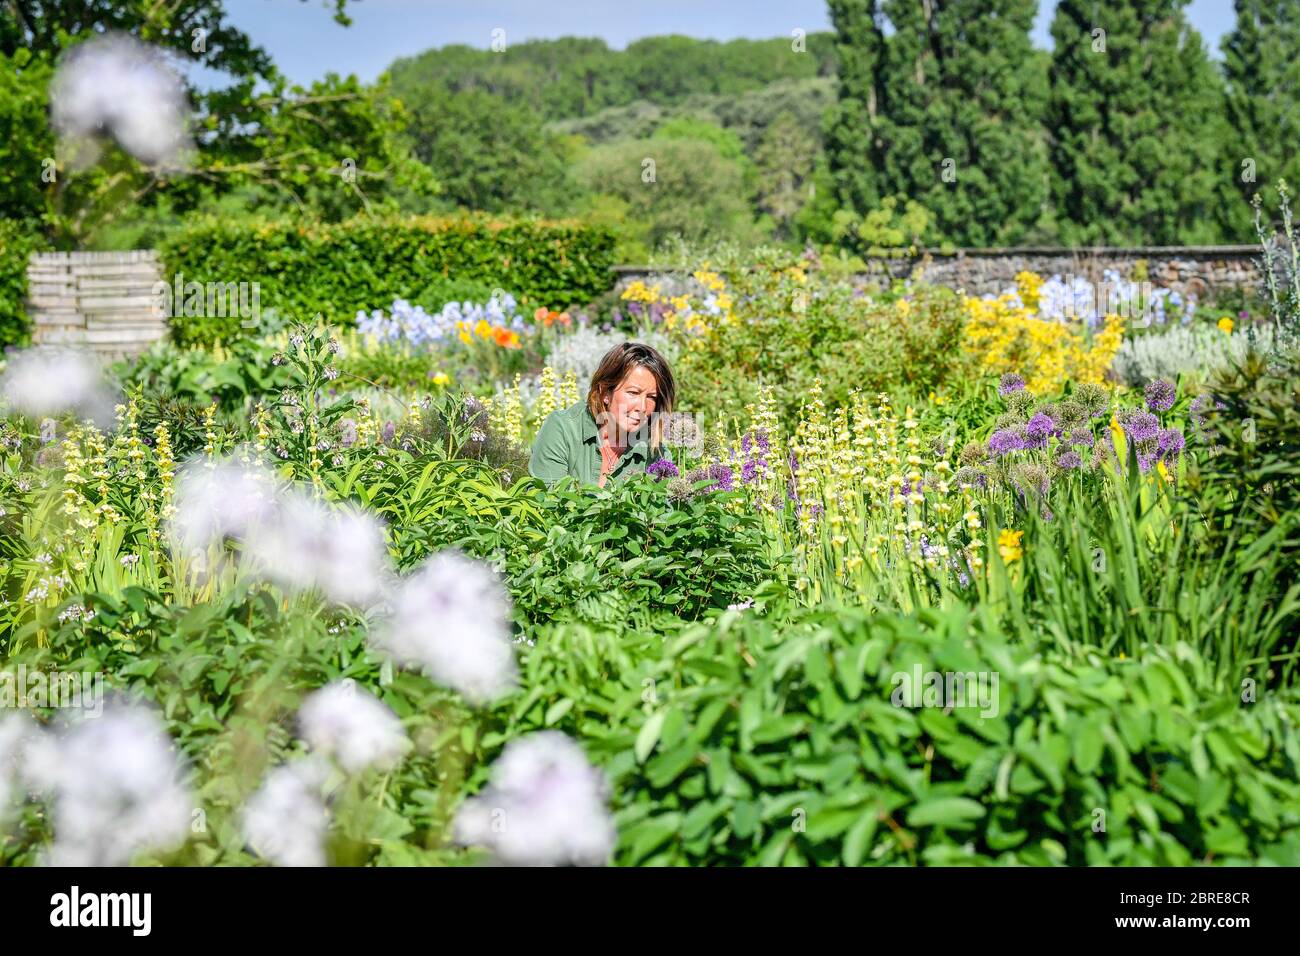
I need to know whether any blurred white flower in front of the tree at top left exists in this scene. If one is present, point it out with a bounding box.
[49,34,190,169]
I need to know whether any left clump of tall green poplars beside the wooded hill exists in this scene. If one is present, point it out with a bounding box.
[827,0,1048,246]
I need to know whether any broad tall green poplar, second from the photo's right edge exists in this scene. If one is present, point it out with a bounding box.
[1047,0,1240,246]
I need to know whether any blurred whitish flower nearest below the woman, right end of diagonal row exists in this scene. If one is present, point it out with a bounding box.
[377,551,517,704]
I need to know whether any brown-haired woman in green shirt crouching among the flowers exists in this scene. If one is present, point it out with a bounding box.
[528,342,677,488]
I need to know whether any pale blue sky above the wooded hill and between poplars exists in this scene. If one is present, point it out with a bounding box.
[226,0,1234,83]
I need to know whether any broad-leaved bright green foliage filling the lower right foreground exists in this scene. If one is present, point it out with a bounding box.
[483,602,1300,866]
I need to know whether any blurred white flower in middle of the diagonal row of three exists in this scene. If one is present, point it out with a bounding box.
[247,493,389,604]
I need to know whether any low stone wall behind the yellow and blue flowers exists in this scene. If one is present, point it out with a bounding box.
[616,246,1261,298]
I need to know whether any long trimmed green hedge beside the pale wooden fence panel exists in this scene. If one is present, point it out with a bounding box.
[160,217,615,342]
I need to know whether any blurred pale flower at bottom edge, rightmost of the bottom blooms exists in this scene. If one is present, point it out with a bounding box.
[454,731,618,866]
